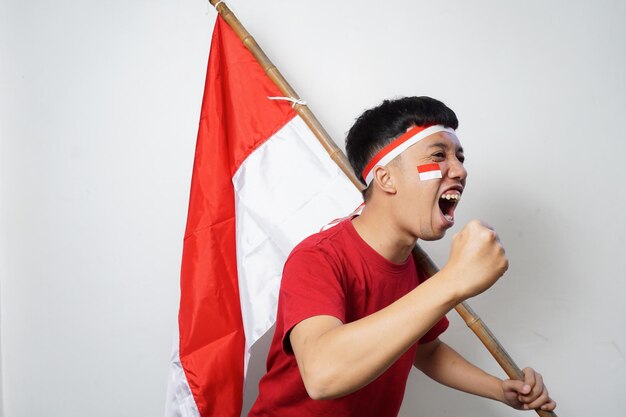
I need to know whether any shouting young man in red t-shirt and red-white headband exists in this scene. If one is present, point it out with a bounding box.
[249,97,556,417]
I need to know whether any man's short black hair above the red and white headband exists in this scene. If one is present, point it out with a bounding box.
[346,96,459,196]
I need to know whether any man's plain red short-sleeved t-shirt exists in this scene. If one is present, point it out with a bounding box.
[248,220,448,417]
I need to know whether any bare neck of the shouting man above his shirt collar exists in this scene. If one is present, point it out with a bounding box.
[352,203,417,263]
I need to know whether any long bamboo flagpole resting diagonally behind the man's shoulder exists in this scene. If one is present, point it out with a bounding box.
[209,0,556,417]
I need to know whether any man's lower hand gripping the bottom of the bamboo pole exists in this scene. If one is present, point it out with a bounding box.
[502,368,556,411]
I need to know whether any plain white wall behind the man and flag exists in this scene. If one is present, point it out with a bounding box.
[0,0,626,417]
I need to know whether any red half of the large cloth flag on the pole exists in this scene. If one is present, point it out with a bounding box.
[178,16,295,417]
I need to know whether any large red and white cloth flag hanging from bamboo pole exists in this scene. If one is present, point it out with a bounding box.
[166,16,362,417]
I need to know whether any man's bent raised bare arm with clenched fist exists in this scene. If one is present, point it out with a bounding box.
[289,221,508,399]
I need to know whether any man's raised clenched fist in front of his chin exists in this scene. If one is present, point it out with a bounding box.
[443,220,509,300]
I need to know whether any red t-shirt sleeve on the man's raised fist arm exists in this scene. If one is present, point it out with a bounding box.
[277,247,346,354]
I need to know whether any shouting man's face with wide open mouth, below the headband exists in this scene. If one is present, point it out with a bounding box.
[390,132,467,240]
